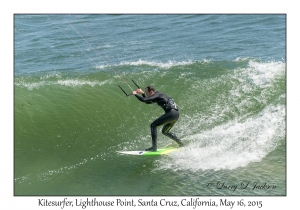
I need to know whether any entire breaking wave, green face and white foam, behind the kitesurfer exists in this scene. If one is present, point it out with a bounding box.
[15,59,286,175]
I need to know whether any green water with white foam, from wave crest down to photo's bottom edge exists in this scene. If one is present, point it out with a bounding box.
[14,59,286,195]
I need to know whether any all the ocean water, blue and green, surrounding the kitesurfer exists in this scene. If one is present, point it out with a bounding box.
[14,14,286,196]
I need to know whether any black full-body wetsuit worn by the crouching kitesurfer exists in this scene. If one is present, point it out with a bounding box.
[135,92,183,151]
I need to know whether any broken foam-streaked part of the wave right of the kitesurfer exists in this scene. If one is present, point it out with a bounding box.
[152,60,286,171]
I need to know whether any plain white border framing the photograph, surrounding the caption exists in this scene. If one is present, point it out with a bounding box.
[0,0,300,210]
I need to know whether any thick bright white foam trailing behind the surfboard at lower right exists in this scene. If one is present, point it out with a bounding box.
[159,105,285,171]
